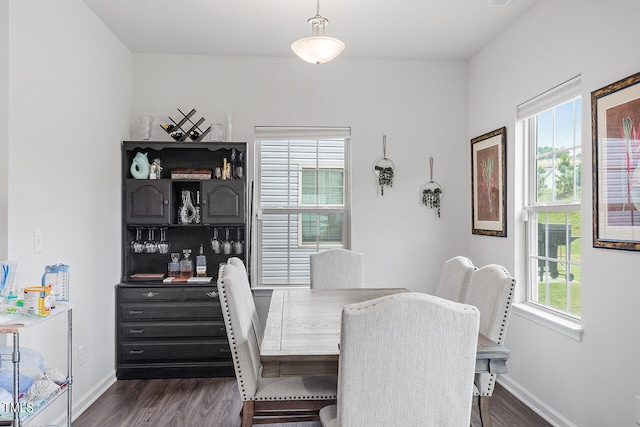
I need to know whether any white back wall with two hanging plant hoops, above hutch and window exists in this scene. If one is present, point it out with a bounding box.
[132,54,470,291]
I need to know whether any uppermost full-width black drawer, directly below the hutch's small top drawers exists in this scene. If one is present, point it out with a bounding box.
[120,302,222,321]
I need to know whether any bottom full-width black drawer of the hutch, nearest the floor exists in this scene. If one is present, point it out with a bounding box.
[120,340,231,363]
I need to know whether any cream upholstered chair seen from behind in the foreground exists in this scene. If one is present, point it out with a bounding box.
[320,293,479,427]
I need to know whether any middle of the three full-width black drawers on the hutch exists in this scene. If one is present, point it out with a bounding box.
[120,320,227,340]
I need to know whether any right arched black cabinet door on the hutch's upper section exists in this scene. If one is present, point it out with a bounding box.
[202,180,245,224]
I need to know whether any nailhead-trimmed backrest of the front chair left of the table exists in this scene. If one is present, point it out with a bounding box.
[218,262,260,401]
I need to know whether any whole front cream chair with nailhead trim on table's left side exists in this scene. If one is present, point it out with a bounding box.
[218,259,337,427]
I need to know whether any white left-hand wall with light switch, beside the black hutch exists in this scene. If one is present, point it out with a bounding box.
[6,0,132,422]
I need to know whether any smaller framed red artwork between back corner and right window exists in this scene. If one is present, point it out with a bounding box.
[471,127,507,237]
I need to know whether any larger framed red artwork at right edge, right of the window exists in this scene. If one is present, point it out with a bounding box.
[591,72,640,251]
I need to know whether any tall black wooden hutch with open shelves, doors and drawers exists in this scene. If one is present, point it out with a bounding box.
[116,141,249,379]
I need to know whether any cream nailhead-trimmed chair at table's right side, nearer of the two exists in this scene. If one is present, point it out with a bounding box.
[464,264,516,427]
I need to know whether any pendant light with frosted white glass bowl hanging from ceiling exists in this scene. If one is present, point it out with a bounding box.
[291,0,344,64]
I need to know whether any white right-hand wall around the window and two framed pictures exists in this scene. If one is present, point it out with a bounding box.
[465,0,640,427]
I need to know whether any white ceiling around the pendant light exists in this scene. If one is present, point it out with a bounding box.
[84,0,538,59]
